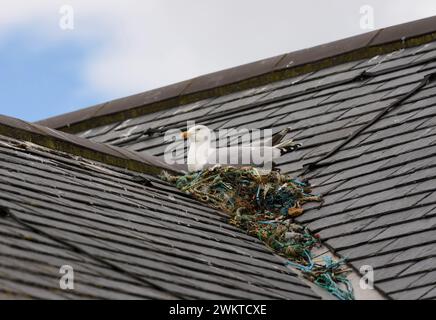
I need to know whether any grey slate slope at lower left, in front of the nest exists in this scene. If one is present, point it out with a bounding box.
[0,129,319,299]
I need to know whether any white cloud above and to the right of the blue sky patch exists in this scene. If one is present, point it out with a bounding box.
[0,0,436,98]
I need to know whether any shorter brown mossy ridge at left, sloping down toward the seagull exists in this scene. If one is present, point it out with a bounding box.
[0,115,182,175]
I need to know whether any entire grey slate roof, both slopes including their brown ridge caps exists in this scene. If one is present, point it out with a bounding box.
[0,17,436,299]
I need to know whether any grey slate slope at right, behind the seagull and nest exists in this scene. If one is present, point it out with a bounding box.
[43,18,436,299]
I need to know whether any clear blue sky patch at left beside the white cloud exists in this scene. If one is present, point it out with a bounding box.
[0,32,106,121]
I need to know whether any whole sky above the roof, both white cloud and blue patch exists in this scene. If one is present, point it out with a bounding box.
[0,0,436,121]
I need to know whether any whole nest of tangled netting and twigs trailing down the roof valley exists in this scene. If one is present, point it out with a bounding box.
[162,166,354,300]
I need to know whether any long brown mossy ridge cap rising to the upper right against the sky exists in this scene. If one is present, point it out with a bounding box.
[38,16,436,133]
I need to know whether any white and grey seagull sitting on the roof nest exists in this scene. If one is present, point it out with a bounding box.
[182,125,301,172]
